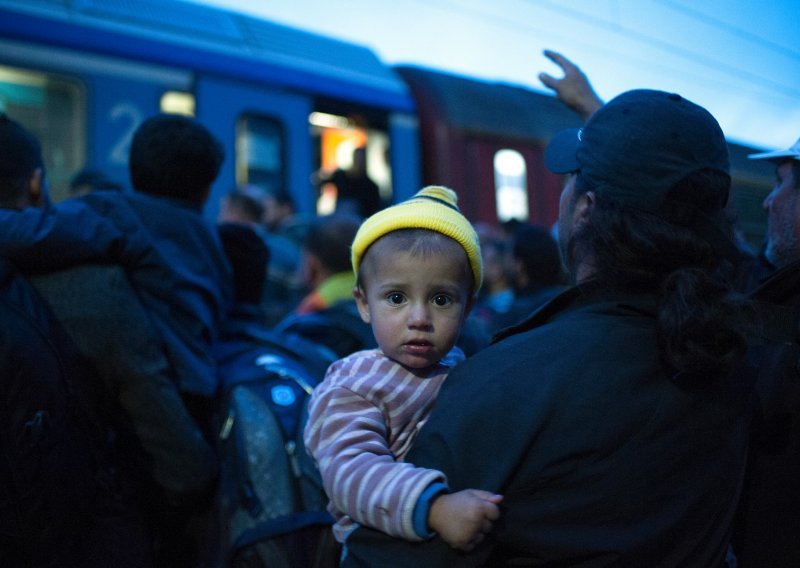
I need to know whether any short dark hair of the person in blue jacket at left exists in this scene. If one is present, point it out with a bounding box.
[129,114,225,205]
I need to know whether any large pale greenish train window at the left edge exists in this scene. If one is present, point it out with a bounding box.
[0,66,86,201]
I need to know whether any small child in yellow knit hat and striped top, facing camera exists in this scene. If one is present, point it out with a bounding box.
[305,186,502,551]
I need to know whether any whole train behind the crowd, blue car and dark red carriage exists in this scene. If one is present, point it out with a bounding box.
[0,0,773,246]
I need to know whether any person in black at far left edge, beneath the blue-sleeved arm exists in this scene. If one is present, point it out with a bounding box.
[0,115,153,568]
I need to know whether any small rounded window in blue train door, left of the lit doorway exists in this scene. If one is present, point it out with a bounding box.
[236,114,285,195]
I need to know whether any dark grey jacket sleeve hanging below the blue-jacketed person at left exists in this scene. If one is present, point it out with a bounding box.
[31,265,217,503]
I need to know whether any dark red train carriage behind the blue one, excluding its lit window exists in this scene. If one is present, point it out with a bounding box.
[397,66,580,224]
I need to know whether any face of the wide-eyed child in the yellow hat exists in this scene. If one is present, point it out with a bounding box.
[355,252,473,369]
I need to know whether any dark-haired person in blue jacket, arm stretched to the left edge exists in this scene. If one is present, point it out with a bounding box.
[0,115,231,398]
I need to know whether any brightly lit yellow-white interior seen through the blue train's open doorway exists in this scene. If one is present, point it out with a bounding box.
[308,112,392,215]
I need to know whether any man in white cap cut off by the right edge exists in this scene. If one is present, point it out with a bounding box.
[733,136,800,568]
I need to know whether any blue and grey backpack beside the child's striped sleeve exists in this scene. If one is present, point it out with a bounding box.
[215,323,338,568]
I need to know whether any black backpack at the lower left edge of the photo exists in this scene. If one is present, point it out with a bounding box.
[0,262,118,567]
